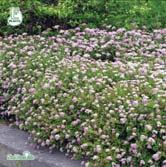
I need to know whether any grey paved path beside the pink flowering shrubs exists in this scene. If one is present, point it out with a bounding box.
[0,124,81,167]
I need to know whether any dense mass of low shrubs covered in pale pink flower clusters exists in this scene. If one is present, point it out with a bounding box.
[0,28,166,167]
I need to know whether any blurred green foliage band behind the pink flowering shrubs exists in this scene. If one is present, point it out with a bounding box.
[0,0,166,35]
